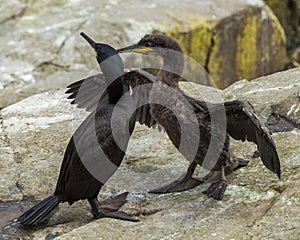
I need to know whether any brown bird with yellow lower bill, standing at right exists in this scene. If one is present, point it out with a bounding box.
[118,34,281,200]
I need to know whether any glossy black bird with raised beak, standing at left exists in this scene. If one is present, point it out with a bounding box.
[15,33,155,226]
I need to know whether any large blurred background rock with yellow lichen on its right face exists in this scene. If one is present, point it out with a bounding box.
[0,0,286,108]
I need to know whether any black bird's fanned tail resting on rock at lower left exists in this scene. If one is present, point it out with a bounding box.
[16,195,61,226]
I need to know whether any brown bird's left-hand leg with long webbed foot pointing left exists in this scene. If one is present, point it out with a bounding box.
[149,161,203,193]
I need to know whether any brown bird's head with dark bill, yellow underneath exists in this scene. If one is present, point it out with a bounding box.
[117,34,182,55]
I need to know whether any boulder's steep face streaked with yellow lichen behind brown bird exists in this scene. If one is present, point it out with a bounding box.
[158,6,286,88]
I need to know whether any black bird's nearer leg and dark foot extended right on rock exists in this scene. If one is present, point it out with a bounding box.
[88,198,139,222]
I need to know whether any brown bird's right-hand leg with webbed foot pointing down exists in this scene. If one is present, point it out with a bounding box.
[203,166,227,200]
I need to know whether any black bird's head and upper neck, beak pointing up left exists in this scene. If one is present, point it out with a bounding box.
[80,32,124,74]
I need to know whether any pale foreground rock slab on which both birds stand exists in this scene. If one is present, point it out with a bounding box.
[0,68,300,240]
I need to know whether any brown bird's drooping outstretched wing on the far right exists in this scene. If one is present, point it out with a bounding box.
[224,100,281,178]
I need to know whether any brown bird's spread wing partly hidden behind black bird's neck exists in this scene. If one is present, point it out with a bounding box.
[66,69,157,130]
